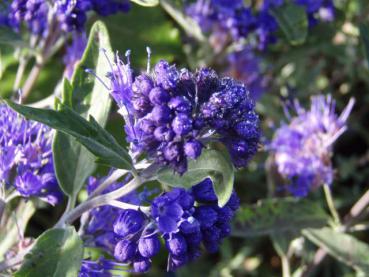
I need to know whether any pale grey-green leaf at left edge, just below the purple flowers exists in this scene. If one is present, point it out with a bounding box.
[0,200,36,260]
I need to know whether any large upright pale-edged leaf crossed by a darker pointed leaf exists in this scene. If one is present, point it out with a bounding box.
[53,22,113,197]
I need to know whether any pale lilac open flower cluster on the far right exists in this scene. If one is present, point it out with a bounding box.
[270,96,354,197]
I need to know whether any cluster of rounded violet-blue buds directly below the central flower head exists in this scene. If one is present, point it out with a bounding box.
[85,176,239,272]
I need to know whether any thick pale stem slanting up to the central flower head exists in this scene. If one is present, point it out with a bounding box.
[55,175,143,227]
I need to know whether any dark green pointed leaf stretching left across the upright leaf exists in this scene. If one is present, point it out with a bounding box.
[6,100,133,170]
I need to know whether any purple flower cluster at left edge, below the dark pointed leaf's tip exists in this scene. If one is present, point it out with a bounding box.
[0,104,62,205]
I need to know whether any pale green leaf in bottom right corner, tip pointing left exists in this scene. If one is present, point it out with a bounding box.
[302,228,369,276]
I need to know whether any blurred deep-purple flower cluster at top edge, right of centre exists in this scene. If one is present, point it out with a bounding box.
[186,0,334,50]
